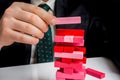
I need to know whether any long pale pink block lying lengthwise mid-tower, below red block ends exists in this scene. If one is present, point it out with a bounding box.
[54,51,83,59]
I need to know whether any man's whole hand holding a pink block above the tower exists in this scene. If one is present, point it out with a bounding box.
[0,2,56,47]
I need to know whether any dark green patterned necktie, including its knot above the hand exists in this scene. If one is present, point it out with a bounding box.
[37,4,53,63]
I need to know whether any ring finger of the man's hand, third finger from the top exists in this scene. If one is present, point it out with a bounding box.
[12,19,44,38]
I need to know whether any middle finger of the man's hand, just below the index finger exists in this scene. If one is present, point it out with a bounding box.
[10,10,48,32]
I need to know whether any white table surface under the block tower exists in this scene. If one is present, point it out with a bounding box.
[0,57,120,80]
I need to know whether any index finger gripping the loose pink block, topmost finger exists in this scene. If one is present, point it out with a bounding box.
[9,2,56,25]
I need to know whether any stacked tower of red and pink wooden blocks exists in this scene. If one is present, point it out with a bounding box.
[54,29,86,80]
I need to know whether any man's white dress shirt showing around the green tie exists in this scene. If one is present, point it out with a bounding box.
[30,0,55,64]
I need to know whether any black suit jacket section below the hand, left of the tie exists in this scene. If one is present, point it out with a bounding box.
[0,43,31,67]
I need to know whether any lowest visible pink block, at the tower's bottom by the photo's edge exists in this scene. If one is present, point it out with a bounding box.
[56,71,85,79]
